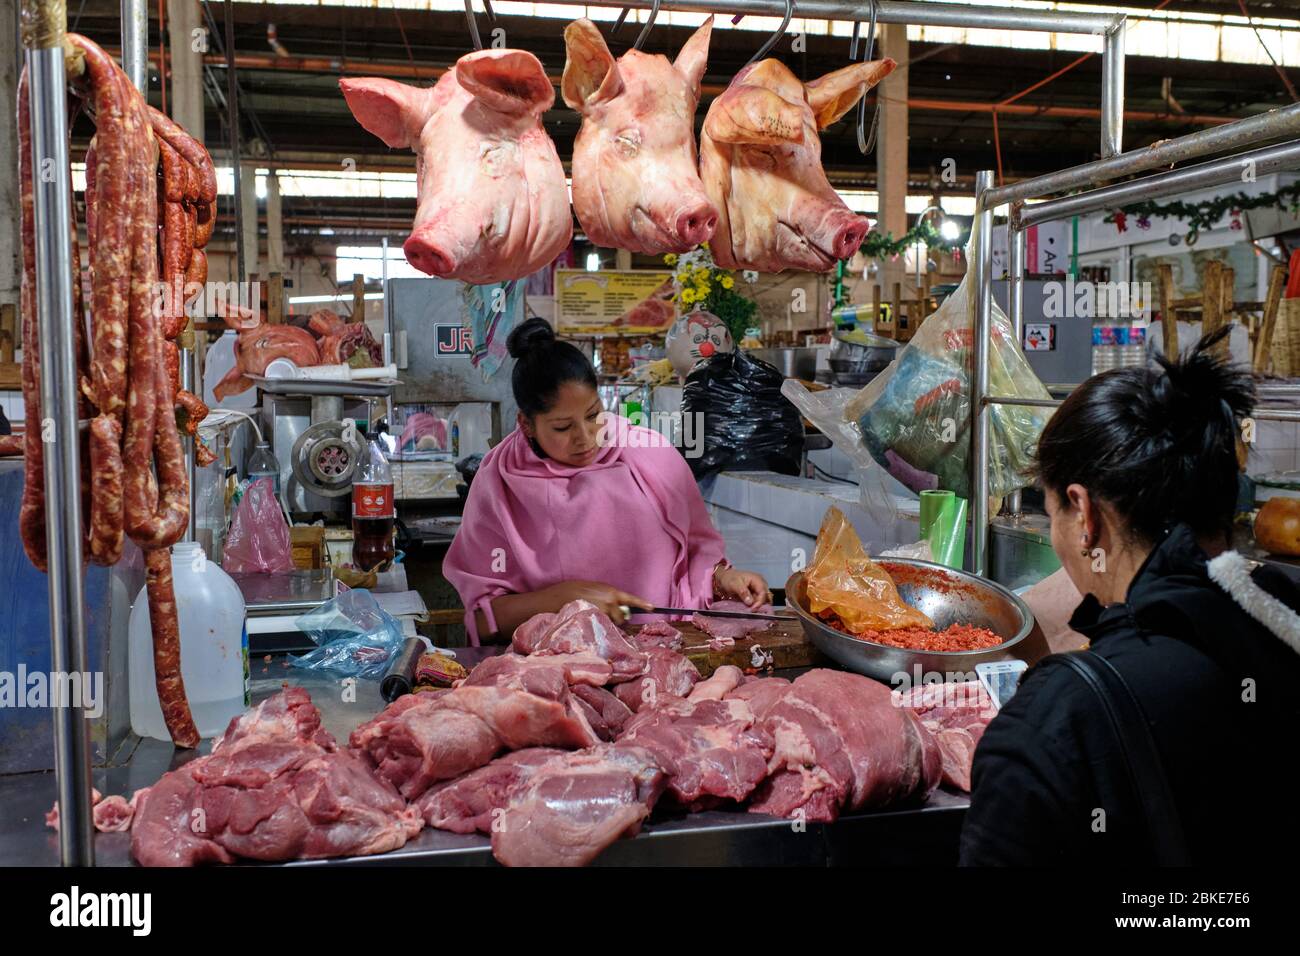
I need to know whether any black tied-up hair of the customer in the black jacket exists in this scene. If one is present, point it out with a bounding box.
[1032,328,1255,545]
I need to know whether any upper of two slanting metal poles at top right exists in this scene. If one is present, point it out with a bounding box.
[985,103,1300,208]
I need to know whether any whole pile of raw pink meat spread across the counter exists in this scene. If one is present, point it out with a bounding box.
[65,601,992,866]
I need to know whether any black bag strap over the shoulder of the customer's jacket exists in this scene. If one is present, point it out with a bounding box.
[1048,650,1191,866]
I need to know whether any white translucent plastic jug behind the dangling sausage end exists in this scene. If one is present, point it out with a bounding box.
[127,541,250,740]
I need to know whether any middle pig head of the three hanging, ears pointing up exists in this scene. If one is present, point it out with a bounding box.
[560,17,718,255]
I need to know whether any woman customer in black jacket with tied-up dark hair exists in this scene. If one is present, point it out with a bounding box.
[961,329,1300,865]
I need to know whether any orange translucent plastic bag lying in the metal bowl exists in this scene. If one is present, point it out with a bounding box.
[805,507,933,633]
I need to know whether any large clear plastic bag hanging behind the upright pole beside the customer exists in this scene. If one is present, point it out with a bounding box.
[844,237,1052,498]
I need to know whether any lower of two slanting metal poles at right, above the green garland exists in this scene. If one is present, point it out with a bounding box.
[1011,140,1300,229]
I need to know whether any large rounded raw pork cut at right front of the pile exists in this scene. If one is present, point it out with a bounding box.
[749,669,941,821]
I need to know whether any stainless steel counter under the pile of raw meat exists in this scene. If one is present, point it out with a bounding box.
[0,658,970,866]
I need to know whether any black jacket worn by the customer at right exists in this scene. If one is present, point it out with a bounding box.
[961,525,1300,866]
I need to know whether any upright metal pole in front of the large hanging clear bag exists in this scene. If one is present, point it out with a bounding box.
[970,169,993,576]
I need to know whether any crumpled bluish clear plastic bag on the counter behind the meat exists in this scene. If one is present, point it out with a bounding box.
[290,588,404,680]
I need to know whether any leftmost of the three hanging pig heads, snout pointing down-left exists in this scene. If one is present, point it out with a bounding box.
[339,49,573,285]
